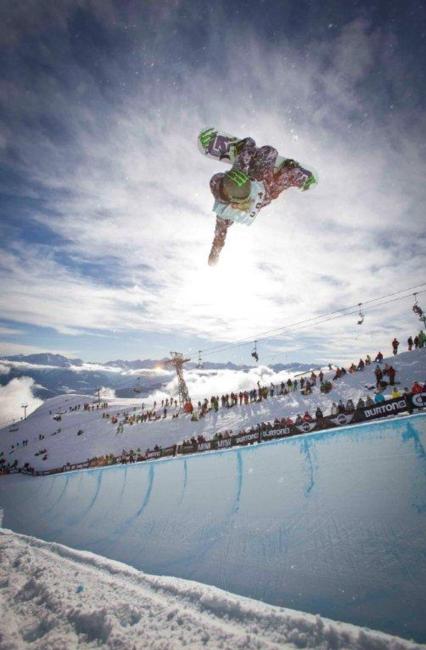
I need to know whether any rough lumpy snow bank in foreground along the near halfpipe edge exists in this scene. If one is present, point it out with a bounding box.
[0,530,420,650]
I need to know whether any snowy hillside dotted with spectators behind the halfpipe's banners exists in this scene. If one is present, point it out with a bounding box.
[0,348,426,469]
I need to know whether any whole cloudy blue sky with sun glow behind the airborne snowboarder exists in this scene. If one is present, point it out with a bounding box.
[0,0,426,363]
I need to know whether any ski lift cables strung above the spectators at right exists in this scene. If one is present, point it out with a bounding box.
[195,282,426,356]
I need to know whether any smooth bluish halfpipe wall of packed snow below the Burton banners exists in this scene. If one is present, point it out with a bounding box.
[0,415,426,642]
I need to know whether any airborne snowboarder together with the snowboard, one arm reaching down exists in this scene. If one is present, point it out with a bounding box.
[199,128,317,266]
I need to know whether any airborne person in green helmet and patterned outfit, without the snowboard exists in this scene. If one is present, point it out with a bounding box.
[209,138,317,266]
